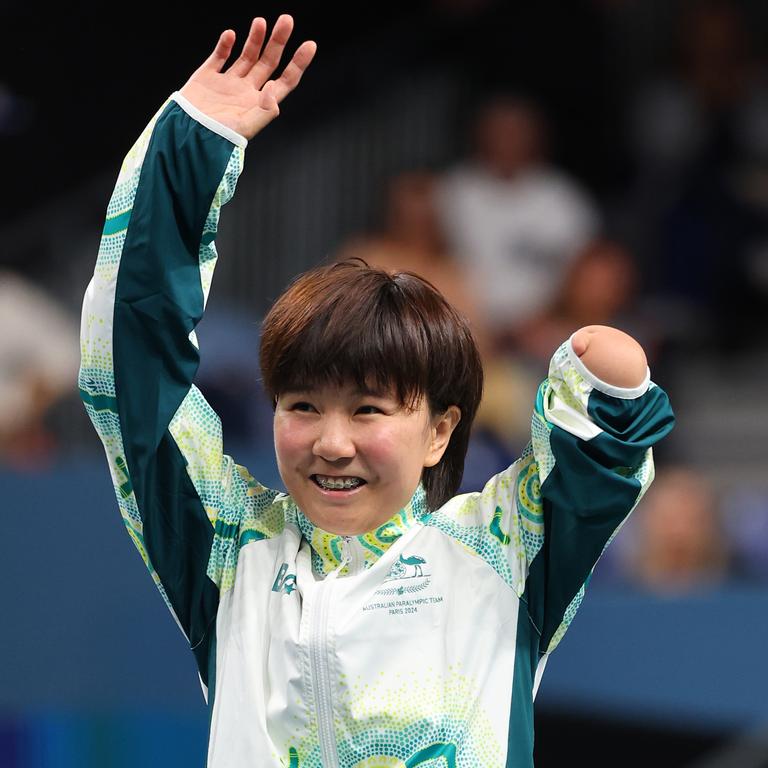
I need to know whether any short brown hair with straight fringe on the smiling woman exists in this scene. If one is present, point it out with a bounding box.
[260,257,483,510]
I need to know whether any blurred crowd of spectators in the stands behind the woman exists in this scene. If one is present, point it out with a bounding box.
[0,2,768,593]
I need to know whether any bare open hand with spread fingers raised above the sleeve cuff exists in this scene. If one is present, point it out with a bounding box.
[180,14,317,139]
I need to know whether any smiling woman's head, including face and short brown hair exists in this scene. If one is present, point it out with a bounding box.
[260,258,483,516]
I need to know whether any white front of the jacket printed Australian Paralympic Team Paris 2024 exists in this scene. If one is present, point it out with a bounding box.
[209,478,538,766]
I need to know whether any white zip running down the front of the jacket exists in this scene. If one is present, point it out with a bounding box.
[309,546,351,768]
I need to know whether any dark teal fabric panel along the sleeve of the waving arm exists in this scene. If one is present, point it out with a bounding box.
[113,103,237,682]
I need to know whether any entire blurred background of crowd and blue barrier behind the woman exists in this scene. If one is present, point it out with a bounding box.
[0,0,768,768]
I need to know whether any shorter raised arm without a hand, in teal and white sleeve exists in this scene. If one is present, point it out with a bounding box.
[516,326,674,653]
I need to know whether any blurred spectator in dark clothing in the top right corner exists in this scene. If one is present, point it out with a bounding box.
[630,0,768,352]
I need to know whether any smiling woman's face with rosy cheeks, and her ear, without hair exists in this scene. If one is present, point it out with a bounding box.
[274,384,460,535]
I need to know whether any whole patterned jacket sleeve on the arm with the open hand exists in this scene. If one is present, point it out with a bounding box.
[78,93,277,685]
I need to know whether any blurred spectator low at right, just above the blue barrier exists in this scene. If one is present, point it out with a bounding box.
[613,466,738,596]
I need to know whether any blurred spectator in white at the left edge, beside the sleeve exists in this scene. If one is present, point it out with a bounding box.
[0,270,80,468]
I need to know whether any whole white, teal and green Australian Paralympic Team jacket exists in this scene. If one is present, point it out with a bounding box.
[79,93,674,768]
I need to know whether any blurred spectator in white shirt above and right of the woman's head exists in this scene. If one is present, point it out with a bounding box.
[438,95,599,334]
